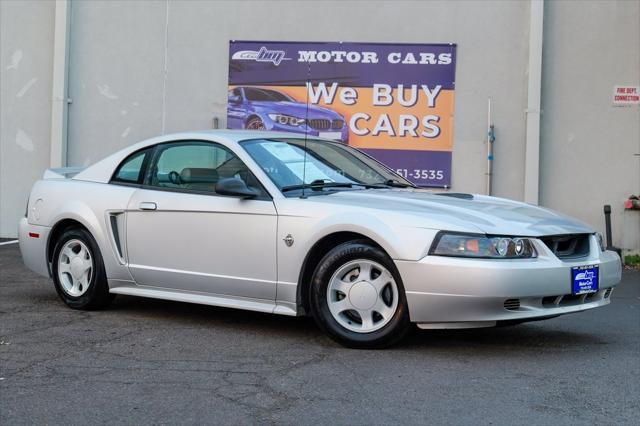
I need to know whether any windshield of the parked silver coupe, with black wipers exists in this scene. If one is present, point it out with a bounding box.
[241,138,413,196]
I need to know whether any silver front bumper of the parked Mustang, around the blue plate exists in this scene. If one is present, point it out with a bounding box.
[396,237,622,328]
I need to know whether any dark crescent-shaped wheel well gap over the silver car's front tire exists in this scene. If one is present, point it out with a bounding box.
[296,231,391,313]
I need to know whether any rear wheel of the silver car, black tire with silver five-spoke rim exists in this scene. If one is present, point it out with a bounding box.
[51,228,115,310]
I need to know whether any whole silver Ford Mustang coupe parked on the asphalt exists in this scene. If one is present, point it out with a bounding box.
[19,130,621,348]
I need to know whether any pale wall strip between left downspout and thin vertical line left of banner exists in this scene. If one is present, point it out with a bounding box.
[67,0,168,166]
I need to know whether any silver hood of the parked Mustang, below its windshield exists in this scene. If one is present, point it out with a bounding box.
[322,189,595,237]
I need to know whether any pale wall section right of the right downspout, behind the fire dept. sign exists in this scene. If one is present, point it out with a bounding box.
[540,1,640,250]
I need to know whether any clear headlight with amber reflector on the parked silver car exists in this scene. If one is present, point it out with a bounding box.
[429,232,538,259]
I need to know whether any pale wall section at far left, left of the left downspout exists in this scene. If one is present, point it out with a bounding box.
[0,1,55,237]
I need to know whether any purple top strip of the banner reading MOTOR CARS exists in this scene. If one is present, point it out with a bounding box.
[229,41,456,90]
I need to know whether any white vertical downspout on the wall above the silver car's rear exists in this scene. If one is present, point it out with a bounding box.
[49,0,71,167]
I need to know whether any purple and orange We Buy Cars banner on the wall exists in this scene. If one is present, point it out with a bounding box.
[227,41,456,187]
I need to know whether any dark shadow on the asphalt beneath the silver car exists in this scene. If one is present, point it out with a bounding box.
[109,296,608,355]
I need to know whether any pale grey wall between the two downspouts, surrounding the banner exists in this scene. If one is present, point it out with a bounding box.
[69,1,529,205]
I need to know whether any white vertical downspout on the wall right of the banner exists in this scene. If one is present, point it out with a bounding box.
[524,0,544,204]
